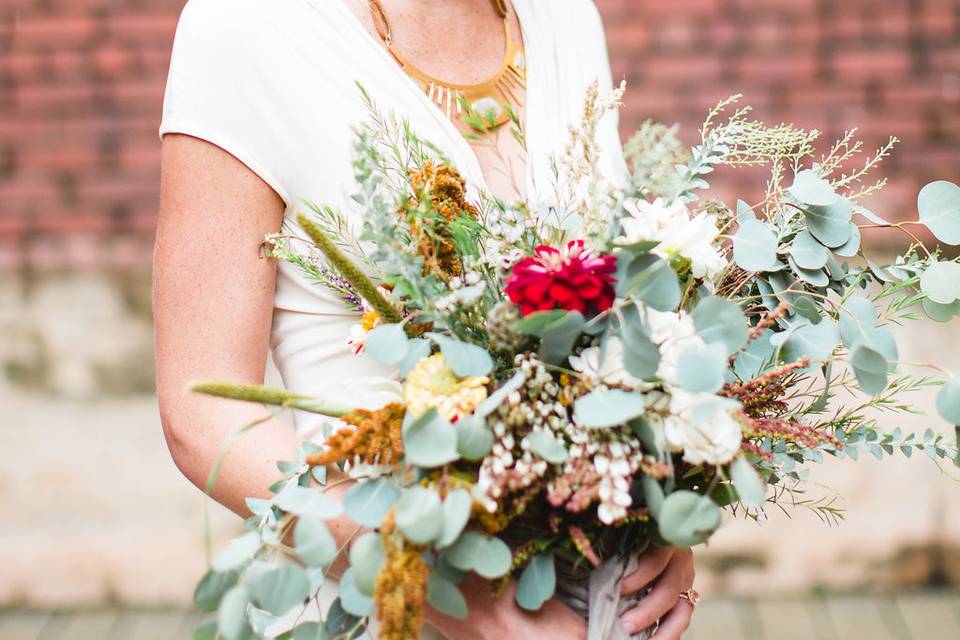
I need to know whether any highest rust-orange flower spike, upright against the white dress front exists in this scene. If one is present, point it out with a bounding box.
[401,161,480,281]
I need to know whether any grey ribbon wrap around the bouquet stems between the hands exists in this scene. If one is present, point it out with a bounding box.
[557,557,656,640]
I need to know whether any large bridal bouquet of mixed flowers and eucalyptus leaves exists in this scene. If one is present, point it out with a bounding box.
[194,87,960,640]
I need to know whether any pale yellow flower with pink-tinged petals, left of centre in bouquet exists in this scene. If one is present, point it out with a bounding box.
[403,353,490,422]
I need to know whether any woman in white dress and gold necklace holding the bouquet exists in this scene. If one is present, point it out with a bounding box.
[155,0,695,640]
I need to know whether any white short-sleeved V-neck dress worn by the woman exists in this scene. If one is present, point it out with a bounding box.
[159,0,624,637]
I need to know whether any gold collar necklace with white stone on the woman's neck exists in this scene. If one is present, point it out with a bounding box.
[368,0,527,128]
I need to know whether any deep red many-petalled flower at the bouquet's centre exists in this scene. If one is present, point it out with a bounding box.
[506,240,617,315]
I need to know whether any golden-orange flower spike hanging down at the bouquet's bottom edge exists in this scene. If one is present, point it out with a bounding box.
[373,509,430,640]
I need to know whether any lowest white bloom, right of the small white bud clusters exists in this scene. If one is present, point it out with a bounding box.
[663,389,743,465]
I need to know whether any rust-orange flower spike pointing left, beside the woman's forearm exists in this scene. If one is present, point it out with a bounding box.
[307,402,406,465]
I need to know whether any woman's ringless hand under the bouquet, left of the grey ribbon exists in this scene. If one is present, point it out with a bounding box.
[427,576,587,640]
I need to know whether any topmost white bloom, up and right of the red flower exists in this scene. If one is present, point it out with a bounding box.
[619,198,727,278]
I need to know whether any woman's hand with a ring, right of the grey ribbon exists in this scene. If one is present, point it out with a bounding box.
[620,547,694,640]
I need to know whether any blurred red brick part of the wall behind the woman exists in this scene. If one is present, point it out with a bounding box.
[0,0,960,271]
